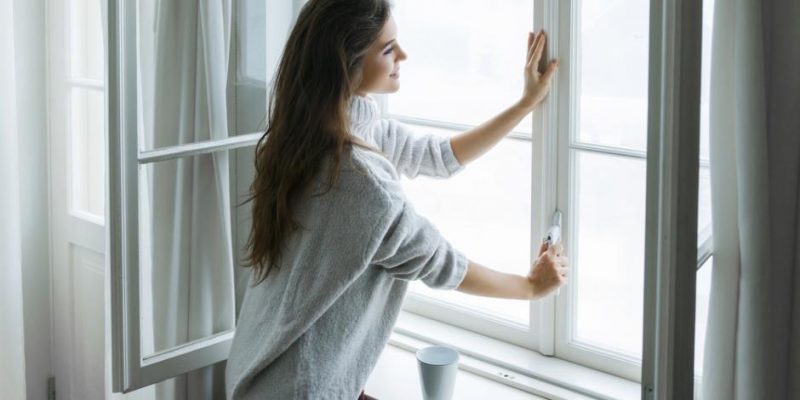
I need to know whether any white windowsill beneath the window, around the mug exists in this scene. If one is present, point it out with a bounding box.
[367,311,641,399]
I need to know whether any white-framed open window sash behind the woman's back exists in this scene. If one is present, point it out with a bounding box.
[103,0,300,393]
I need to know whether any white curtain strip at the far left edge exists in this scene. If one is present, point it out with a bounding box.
[0,0,26,399]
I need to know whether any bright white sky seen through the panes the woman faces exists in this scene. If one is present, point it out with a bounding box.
[388,0,710,368]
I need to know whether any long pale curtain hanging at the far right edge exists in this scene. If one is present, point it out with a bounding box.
[703,0,800,400]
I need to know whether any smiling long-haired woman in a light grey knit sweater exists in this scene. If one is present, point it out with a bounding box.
[226,0,566,399]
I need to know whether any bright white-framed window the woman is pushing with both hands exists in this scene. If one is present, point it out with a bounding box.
[381,0,713,380]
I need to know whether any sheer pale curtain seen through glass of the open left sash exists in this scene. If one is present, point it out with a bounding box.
[140,0,234,400]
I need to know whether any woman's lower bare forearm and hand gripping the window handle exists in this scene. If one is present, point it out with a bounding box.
[457,244,568,300]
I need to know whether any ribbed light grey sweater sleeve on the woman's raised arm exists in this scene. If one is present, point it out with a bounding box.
[375,119,464,178]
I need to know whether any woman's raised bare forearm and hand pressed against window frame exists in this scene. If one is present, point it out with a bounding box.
[450,31,558,165]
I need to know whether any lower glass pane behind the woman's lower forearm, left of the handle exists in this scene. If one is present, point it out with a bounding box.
[403,131,531,325]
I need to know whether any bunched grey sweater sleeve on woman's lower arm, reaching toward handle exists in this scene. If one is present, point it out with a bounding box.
[372,201,467,290]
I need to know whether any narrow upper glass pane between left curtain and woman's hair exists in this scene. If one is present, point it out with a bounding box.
[235,0,267,135]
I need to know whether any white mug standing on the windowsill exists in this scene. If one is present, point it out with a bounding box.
[417,346,459,400]
